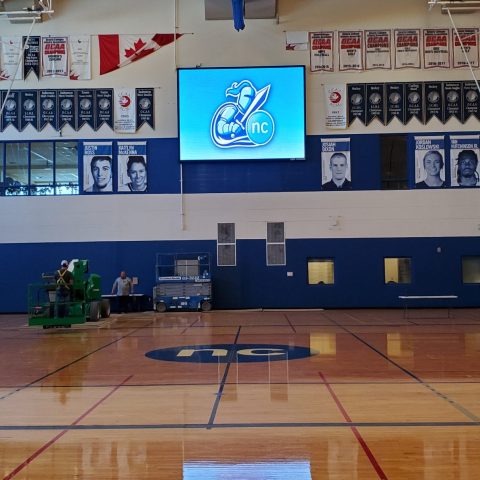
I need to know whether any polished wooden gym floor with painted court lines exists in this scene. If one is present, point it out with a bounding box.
[0,309,480,480]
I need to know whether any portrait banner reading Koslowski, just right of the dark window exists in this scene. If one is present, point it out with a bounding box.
[415,136,445,188]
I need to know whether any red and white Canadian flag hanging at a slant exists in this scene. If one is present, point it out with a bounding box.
[98,33,182,75]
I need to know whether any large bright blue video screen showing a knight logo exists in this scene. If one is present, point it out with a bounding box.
[178,66,305,161]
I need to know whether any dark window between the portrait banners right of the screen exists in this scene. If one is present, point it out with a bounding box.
[380,135,408,190]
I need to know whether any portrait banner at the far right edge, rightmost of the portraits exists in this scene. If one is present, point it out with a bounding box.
[450,135,480,187]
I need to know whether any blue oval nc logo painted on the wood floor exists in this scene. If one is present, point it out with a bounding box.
[145,343,317,363]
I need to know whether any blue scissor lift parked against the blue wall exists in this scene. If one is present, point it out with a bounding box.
[153,253,212,312]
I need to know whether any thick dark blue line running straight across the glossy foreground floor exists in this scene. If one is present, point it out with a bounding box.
[0,422,480,432]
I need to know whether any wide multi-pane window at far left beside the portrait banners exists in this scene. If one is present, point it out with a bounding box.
[0,142,78,195]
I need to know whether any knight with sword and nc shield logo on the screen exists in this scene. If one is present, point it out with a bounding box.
[210,80,275,148]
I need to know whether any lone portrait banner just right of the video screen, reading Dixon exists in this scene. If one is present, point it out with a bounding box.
[321,138,352,191]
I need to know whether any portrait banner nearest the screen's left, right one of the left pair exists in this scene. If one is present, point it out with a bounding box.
[117,142,147,192]
